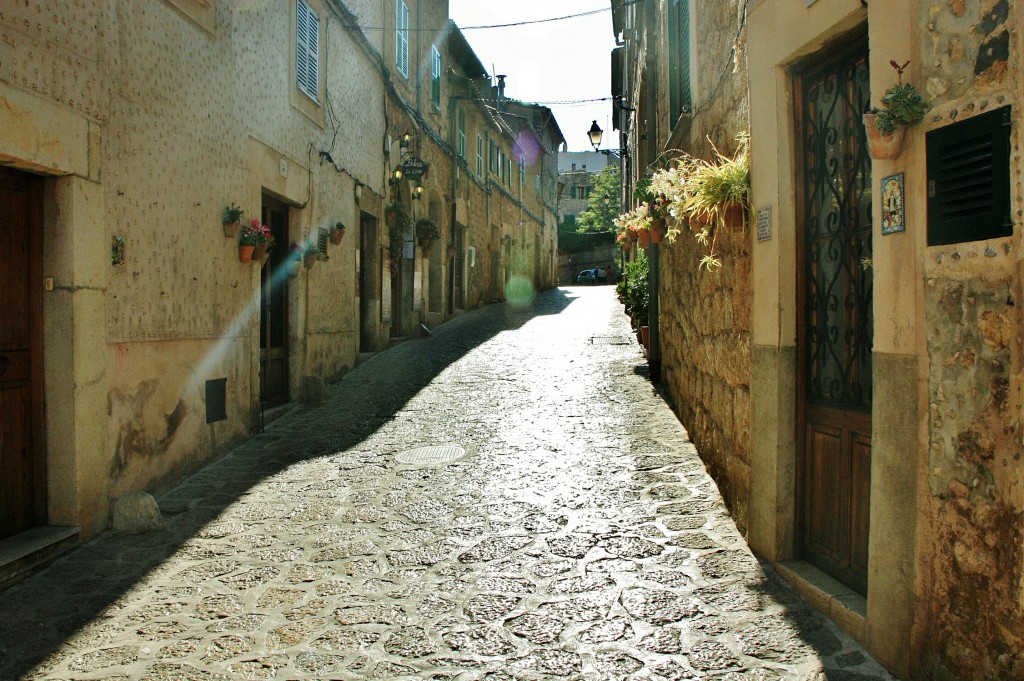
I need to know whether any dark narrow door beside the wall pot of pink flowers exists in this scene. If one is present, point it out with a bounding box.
[259,197,291,408]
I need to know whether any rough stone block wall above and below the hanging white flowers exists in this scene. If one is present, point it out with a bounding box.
[658,0,753,530]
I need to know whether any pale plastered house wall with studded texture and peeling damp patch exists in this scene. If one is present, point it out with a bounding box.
[0,0,384,533]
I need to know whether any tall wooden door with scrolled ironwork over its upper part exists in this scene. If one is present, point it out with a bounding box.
[797,35,872,593]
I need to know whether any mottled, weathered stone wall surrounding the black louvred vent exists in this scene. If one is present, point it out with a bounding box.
[915,0,1024,679]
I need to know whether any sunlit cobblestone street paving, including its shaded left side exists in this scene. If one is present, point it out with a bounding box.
[0,287,891,681]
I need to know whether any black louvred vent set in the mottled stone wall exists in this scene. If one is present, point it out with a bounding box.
[925,107,1014,246]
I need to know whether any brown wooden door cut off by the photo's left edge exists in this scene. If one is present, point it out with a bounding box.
[0,168,46,539]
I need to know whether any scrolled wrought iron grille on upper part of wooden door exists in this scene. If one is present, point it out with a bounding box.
[803,59,872,410]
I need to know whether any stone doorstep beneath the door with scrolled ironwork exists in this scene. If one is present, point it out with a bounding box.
[772,560,868,648]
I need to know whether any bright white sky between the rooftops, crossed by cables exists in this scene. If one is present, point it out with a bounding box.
[449,0,617,152]
